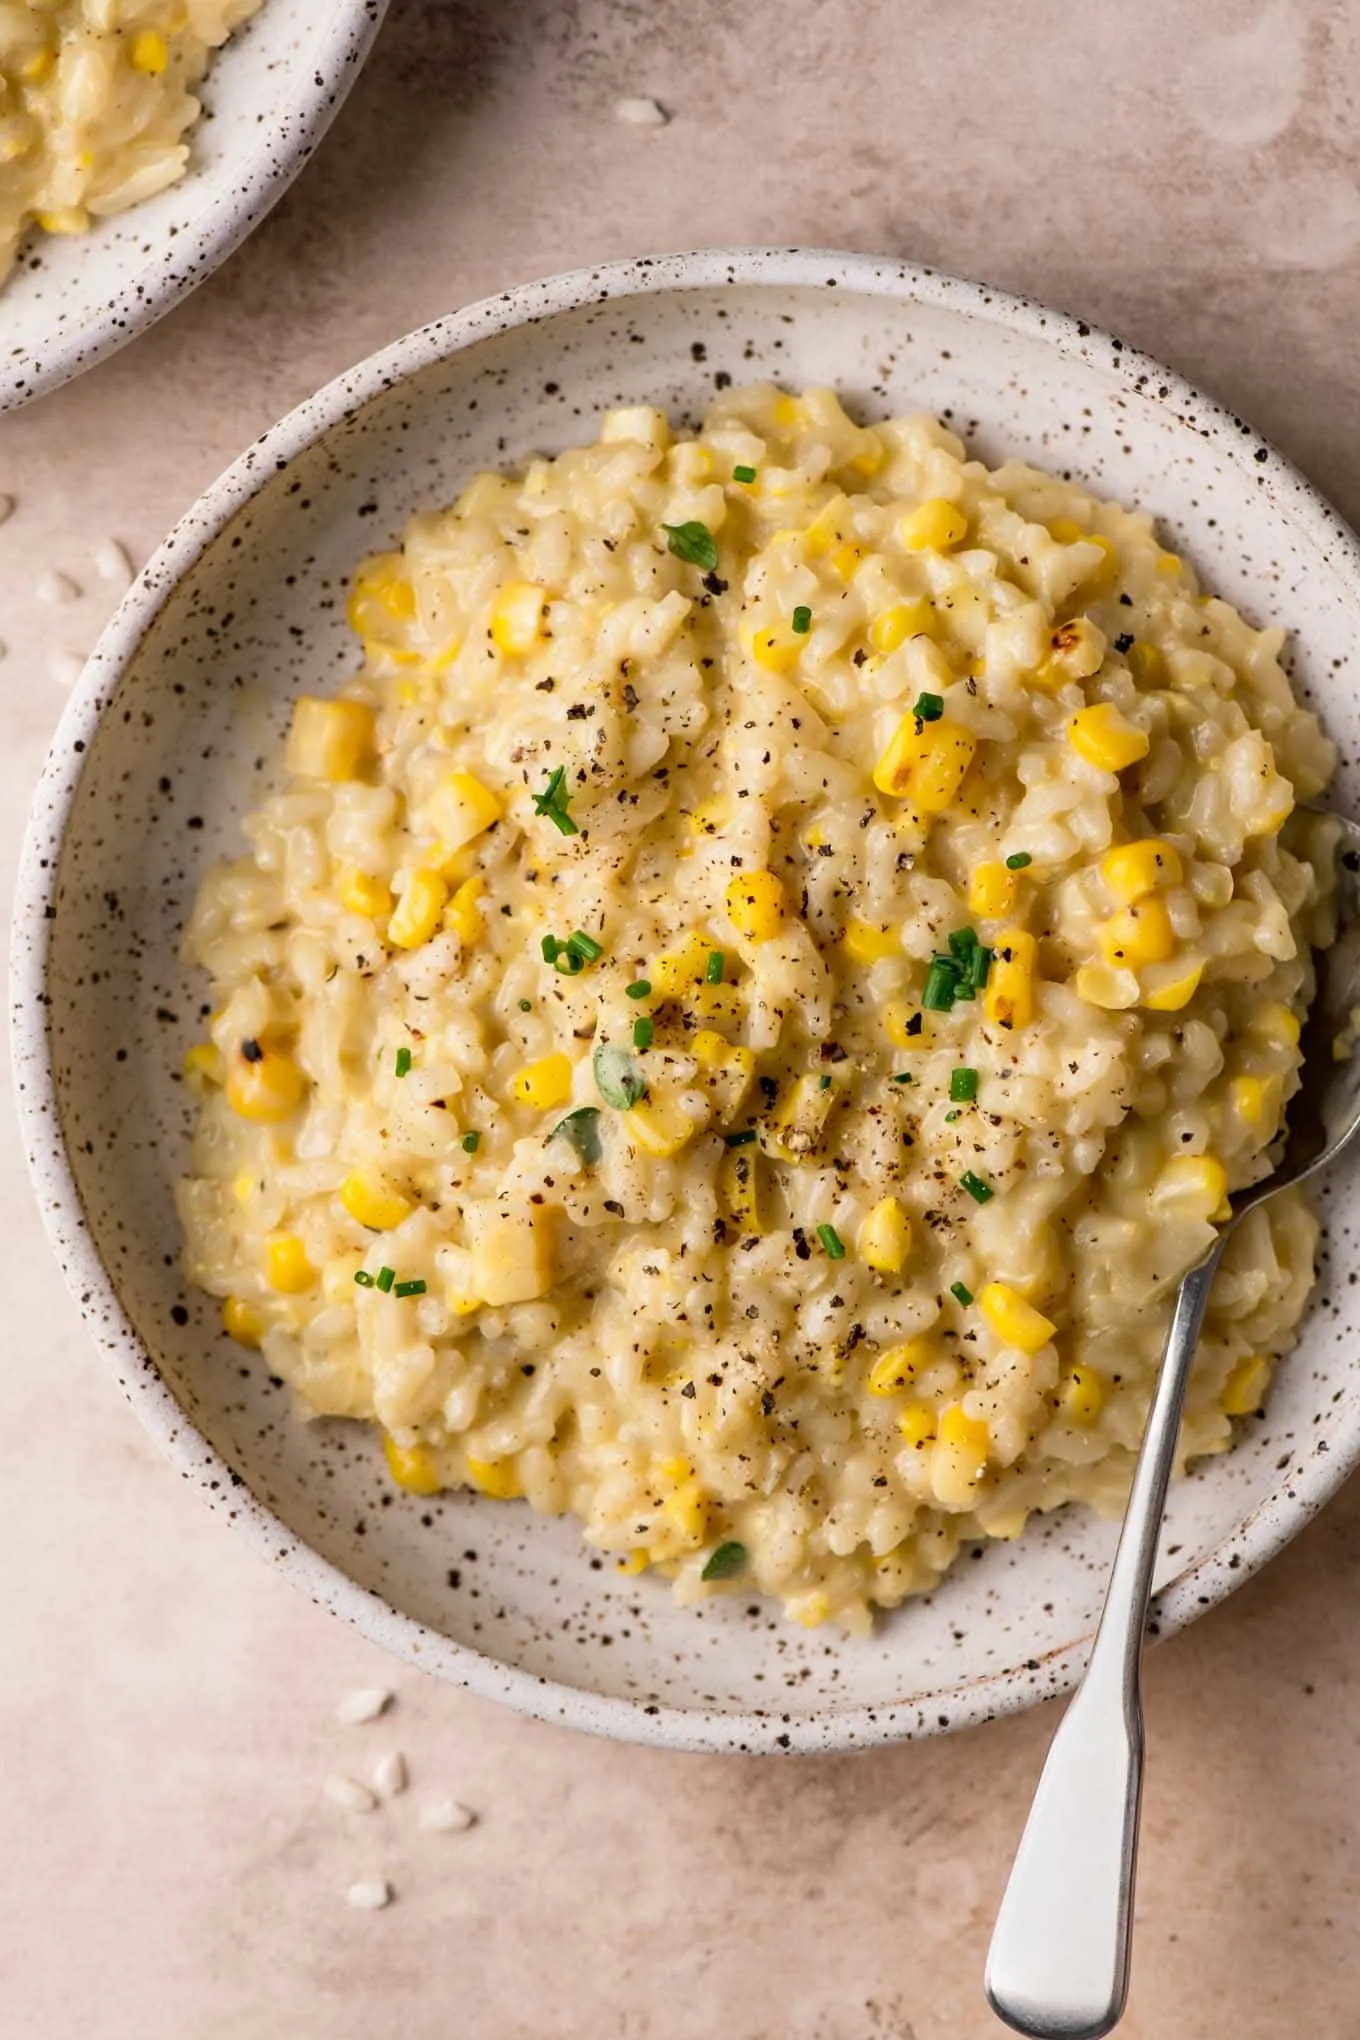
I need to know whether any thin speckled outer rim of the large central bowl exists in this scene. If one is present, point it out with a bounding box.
[10,247,1360,1752]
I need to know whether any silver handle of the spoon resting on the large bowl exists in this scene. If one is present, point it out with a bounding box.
[987,1234,1225,2040]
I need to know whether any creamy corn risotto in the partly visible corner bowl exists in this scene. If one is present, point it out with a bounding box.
[0,0,261,282]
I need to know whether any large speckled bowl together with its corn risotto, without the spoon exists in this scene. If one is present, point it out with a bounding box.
[14,253,1360,1748]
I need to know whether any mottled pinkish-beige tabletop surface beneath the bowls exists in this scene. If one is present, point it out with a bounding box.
[0,0,1360,2040]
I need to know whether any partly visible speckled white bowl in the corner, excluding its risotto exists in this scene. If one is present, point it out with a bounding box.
[0,0,387,410]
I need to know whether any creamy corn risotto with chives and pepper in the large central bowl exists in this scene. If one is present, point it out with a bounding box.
[179,386,1333,1628]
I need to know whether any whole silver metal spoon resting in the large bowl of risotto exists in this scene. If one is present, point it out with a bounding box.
[987,816,1360,2040]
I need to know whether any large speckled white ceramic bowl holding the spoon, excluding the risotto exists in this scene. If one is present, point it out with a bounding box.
[14,253,1360,1750]
